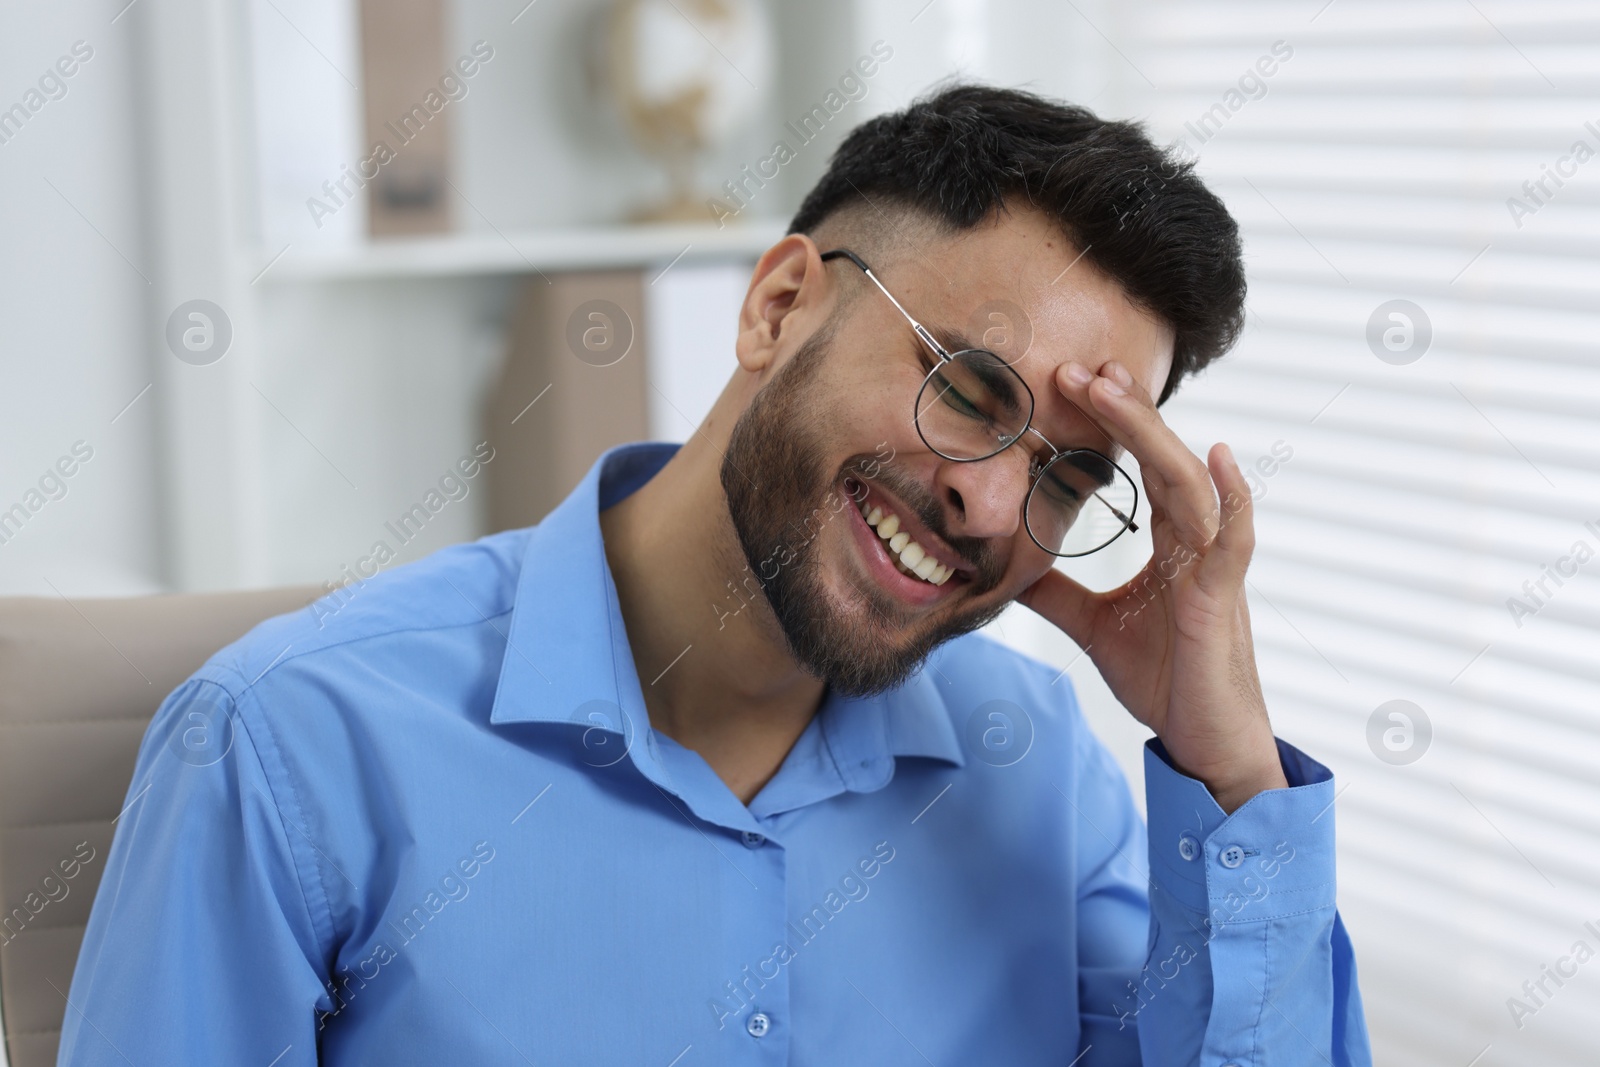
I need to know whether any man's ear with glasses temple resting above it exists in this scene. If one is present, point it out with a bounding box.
[734,234,834,374]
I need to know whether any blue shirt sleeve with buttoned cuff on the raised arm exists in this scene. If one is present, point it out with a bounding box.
[1115,739,1371,1067]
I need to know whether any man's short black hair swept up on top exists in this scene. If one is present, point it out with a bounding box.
[789,85,1245,402]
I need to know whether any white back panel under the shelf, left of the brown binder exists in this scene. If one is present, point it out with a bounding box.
[256,277,515,584]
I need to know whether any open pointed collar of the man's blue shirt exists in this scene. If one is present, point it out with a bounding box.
[490,443,965,792]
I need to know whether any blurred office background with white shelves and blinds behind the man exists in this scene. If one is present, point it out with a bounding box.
[0,0,1600,1067]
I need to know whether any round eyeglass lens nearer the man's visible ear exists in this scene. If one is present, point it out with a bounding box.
[917,349,1034,459]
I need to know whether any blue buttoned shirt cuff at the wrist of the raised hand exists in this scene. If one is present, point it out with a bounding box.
[1144,737,1334,926]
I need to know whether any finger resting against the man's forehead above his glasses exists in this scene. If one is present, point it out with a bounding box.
[1056,360,1218,549]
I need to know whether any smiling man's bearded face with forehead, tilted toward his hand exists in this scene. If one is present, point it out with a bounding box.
[722,213,1173,693]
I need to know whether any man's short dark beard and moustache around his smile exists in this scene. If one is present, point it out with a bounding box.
[720,323,1005,696]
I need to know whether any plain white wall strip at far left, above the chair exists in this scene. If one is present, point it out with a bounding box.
[0,3,162,597]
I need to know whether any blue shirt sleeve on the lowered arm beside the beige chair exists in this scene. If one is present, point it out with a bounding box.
[58,678,331,1067]
